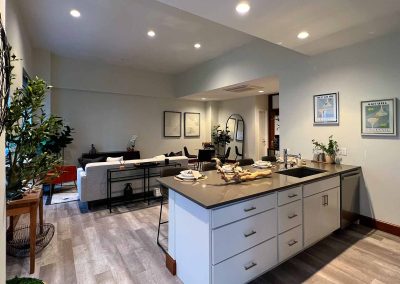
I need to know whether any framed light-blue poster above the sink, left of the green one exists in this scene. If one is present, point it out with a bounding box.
[314,93,339,125]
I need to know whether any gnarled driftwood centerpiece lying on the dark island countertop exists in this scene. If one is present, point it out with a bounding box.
[213,158,272,183]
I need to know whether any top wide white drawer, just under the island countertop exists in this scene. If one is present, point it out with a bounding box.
[211,193,276,228]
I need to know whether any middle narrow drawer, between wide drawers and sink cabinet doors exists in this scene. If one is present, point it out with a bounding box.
[278,200,303,234]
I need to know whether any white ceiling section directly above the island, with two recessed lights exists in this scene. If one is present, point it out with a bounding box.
[158,0,400,55]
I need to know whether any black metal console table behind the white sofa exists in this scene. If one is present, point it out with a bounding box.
[107,162,181,213]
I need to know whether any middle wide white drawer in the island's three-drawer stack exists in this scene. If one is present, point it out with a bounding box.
[211,208,277,264]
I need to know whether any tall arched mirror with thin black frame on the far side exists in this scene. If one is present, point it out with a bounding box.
[225,114,245,161]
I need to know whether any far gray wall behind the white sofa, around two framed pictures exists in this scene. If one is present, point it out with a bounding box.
[51,56,208,164]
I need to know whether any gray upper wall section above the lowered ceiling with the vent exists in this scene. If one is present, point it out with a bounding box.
[175,39,306,97]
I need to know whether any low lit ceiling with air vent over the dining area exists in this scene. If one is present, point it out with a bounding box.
[184,76,279,101]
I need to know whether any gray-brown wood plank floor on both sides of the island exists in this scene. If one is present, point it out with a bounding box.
[7,202,400,284]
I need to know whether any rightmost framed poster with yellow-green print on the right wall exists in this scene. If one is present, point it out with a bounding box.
[361,98,397,136]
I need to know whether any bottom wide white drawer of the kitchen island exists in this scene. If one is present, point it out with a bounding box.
[212,238,278,284]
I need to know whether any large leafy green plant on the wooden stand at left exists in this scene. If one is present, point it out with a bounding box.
[5,78,69,199]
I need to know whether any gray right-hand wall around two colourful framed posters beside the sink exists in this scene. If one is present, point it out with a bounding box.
[279,33,400,225]
